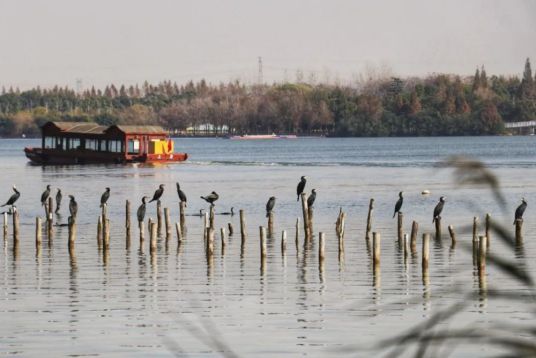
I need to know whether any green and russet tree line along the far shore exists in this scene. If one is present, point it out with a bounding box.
[0,59,536,137]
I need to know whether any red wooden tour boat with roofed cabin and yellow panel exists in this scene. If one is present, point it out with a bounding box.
[24,122,188,164]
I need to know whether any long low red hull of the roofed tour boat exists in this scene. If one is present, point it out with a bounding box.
[24,147,188,165]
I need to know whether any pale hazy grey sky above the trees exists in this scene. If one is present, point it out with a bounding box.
[0,0,536,88]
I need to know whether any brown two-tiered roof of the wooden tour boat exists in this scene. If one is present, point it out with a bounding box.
[43,122,167,135]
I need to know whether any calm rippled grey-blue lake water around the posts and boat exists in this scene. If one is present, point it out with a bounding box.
[0,137,536,357]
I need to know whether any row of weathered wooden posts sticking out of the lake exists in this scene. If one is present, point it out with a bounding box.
[3,193,523,274]
